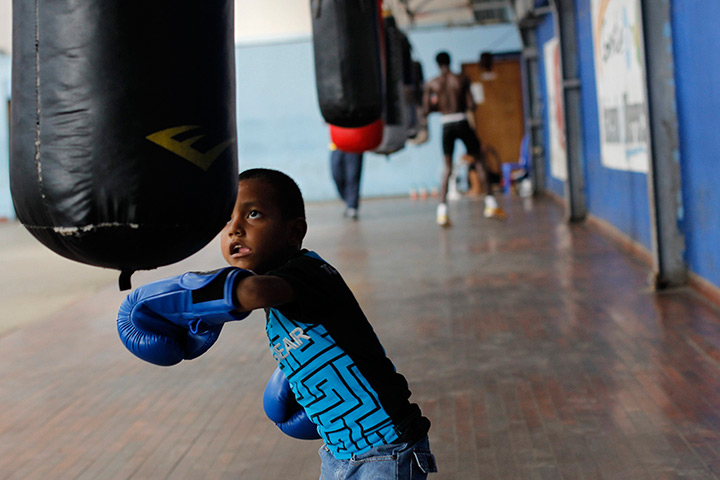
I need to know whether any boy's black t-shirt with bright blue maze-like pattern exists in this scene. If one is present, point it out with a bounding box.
[266,250,430,459]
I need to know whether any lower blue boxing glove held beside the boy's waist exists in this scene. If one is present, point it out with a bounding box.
[263,368,320,440]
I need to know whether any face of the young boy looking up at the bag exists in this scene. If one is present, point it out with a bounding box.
[220,180,306,274]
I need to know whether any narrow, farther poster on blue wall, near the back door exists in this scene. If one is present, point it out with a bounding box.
[543,38,567,181]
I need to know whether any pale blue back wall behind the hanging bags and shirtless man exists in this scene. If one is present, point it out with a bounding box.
[236,25,521,200]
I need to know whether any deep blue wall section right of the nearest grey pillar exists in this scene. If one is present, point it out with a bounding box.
[671,1,720,286]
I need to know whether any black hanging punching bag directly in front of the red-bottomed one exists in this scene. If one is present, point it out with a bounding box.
[310,0,383,128]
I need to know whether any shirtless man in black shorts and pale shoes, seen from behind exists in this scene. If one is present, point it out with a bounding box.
[423,52,507,227]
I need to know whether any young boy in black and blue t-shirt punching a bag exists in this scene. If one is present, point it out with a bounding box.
[118,169,436,480]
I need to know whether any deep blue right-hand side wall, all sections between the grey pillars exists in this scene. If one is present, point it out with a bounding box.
[537,0,720,287]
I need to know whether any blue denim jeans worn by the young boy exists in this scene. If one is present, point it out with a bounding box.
[318,437,437,480]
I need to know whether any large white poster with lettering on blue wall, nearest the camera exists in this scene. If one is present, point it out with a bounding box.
[591,0,649,173]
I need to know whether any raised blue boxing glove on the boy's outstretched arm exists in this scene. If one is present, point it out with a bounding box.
[117,267,252,366]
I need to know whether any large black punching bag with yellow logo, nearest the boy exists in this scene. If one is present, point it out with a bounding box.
[10,0,238,284]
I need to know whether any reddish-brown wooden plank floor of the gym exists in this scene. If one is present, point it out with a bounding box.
[0,193,720,480]
